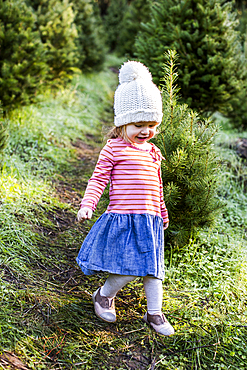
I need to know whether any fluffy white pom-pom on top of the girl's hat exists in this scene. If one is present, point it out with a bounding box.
[119,61,152,84]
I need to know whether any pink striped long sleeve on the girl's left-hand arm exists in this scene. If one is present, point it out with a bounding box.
[81,143,114,211]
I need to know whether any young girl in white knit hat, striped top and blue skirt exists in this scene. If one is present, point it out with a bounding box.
[77,61,174,335]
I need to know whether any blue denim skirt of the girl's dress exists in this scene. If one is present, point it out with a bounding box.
[76,213,164,280]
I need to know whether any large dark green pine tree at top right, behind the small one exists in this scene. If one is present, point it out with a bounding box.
[136,0,245,117]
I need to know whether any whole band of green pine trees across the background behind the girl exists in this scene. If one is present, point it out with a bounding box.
[0,0,247,129]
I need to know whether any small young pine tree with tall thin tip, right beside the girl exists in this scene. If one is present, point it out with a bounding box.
[153,51,220,247]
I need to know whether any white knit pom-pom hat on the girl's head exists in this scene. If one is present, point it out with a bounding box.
[114,61,163,127]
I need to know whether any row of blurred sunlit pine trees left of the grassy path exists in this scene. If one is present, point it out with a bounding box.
[0,0,106,111]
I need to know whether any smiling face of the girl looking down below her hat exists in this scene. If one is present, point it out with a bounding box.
[126,122,158,144]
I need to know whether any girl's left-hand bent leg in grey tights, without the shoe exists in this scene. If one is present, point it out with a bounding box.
[100,274,137,298]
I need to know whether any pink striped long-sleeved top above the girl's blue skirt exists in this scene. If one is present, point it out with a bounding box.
[81,138,169,223]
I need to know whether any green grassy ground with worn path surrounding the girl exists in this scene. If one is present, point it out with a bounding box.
[0,57,247,370]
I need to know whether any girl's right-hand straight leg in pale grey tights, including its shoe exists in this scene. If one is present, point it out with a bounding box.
[143,276,174,336]
